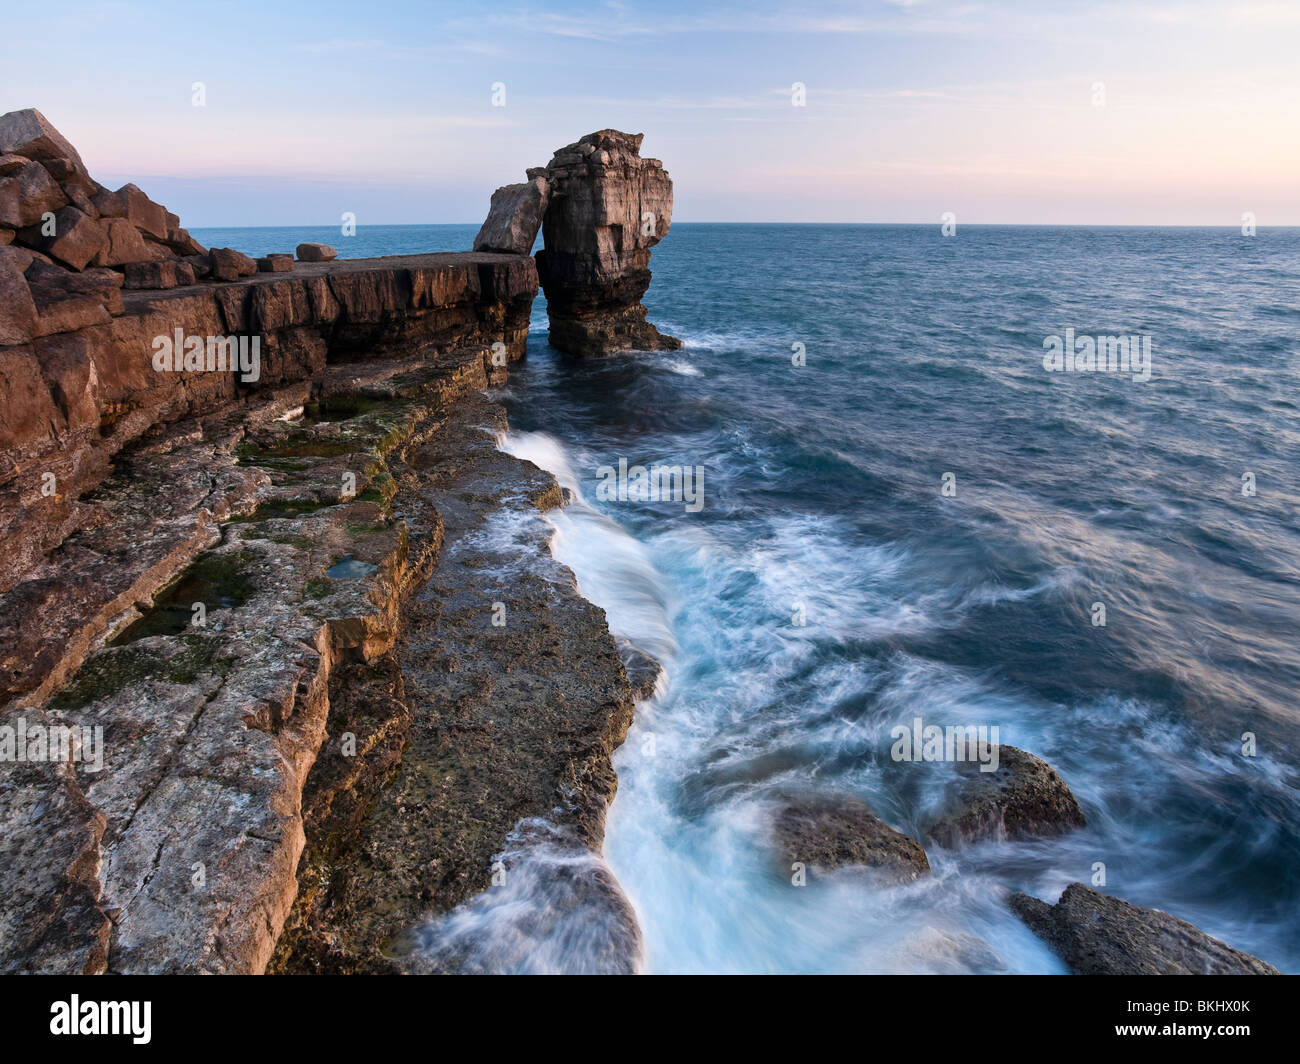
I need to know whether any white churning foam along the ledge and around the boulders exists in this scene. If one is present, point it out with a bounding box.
[483,421,1284,973]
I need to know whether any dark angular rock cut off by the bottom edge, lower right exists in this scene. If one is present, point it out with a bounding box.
[1010,883,1281,976]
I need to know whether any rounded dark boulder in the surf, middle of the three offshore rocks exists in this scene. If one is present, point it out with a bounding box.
[926,745,1087,847]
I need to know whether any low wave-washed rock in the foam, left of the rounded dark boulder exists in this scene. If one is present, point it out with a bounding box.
[772,793,930,884]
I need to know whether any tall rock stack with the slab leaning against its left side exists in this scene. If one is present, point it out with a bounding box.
[475,129,681,355]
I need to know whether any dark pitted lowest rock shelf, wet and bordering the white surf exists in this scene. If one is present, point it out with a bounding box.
[277,382,640,972]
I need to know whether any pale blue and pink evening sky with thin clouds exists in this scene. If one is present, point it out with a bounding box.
[0,0,1300,228]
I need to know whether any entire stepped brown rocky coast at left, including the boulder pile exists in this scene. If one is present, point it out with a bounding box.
[0,112,637,973]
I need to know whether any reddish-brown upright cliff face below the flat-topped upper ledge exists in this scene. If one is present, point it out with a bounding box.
[0,255,536,700]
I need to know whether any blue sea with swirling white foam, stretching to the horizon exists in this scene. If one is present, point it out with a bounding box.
[198,225,1300,972]
